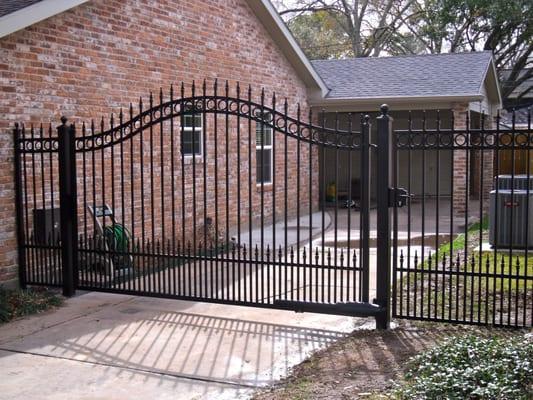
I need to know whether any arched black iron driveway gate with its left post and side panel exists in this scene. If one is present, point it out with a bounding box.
[15,83,388,325]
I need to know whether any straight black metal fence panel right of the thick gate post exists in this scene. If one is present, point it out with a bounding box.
[392,110,533,326]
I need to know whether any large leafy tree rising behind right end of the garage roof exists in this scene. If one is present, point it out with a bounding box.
[402,0,533,99]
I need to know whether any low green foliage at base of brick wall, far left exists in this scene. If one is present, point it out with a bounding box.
[0,287,63,323]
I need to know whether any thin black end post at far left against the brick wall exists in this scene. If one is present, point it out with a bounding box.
[13,123,26,289]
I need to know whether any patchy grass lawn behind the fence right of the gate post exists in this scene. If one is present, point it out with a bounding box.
[396,218,533,325]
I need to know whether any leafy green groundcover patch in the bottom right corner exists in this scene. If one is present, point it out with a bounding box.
[395,335,533,400]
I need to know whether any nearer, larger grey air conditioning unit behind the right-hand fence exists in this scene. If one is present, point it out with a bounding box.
[489,190,533,248]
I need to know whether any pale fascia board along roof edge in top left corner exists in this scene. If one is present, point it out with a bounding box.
[0,0,89,38]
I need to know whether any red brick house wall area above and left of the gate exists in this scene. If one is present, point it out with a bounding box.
[0,0,318,282]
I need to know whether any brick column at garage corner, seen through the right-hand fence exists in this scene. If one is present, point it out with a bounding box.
[452,103,469,217]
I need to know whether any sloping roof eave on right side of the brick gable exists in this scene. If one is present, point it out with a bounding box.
[247,0,329,97]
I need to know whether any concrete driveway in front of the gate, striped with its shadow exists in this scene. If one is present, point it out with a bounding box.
[0,293,374,400]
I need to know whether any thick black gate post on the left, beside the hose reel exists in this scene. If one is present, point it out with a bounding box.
[57,117,78,297]
